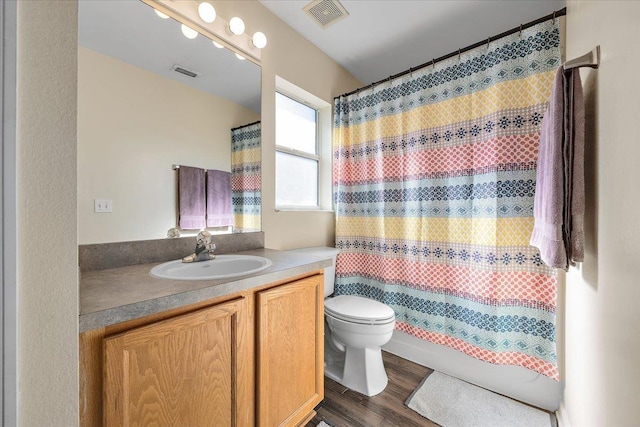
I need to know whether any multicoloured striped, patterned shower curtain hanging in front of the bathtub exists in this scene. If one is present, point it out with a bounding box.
[333,20,560,380]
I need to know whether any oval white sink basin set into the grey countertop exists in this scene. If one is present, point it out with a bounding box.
[151,255,271,280]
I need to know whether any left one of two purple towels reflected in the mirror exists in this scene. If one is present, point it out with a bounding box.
[178,166,206,230]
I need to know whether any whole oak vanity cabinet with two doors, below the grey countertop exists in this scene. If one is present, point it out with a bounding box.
[80,273,324,427]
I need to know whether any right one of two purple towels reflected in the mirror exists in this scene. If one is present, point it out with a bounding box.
[207,170,233,227]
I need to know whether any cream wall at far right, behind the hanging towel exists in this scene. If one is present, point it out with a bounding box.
[561,0,640,427]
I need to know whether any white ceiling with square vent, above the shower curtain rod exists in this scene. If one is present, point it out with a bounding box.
[259,0,565,84]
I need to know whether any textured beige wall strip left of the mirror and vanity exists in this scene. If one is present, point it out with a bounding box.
[17,1,78,427]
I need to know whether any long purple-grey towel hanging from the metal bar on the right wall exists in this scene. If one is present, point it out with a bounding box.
[530,67,584,270]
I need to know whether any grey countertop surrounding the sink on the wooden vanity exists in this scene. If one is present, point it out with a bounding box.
[79,249,331,332]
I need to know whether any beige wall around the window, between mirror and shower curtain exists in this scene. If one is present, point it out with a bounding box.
[209,1,363,249]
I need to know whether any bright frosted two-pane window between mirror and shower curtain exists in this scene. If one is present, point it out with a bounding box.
[276,92,320,209]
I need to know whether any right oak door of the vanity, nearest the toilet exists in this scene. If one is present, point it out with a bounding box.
[256,276,324,427]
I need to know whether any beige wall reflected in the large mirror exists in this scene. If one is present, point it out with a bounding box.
[78,47,260,244]
